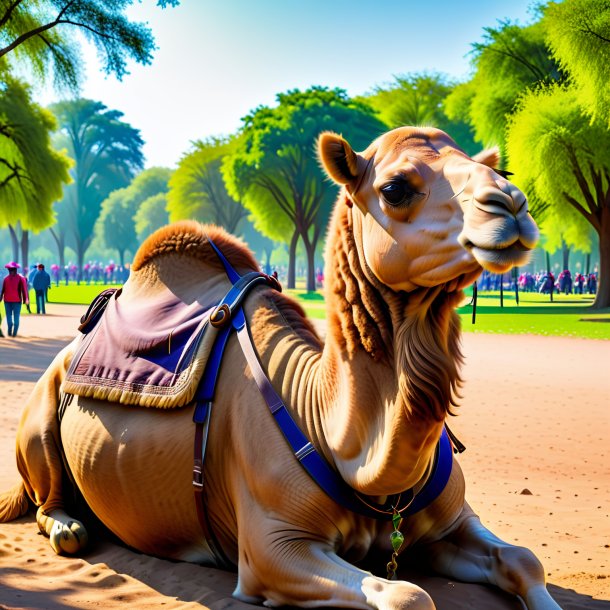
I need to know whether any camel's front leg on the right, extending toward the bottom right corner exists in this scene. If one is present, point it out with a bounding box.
[423,503,561,610]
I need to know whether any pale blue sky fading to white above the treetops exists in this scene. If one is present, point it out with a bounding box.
[34,0,532,168]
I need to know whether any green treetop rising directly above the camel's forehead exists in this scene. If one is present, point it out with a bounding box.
[364,73,479,155]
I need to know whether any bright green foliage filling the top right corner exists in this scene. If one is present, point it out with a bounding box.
[544,0,610,124]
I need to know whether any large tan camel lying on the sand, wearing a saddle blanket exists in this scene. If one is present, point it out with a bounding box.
[0,127,559,610]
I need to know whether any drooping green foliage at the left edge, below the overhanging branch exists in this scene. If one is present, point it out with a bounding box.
[0,66,70,231]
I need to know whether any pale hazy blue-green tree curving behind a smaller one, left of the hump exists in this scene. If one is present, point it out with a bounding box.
[96,167,172,266]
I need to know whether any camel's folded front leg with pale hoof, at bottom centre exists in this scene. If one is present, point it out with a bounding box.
[233,520,435,610]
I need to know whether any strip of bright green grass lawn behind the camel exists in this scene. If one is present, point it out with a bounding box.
[40,284,610,339]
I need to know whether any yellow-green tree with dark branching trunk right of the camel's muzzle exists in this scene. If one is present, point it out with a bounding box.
[508,86,610,306]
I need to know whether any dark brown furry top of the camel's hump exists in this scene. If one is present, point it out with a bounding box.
[132,220,259,273]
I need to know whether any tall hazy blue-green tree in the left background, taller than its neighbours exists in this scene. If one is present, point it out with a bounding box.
[52,99,144,274]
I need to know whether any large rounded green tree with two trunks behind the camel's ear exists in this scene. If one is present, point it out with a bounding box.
[223,87,386,290]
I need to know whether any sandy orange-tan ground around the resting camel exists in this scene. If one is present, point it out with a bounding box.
[0,304,610,610]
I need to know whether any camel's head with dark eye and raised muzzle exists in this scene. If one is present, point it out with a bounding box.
[318,127,538,291]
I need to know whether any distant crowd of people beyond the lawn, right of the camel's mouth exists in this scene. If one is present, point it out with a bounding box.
[478,269,598,294]
